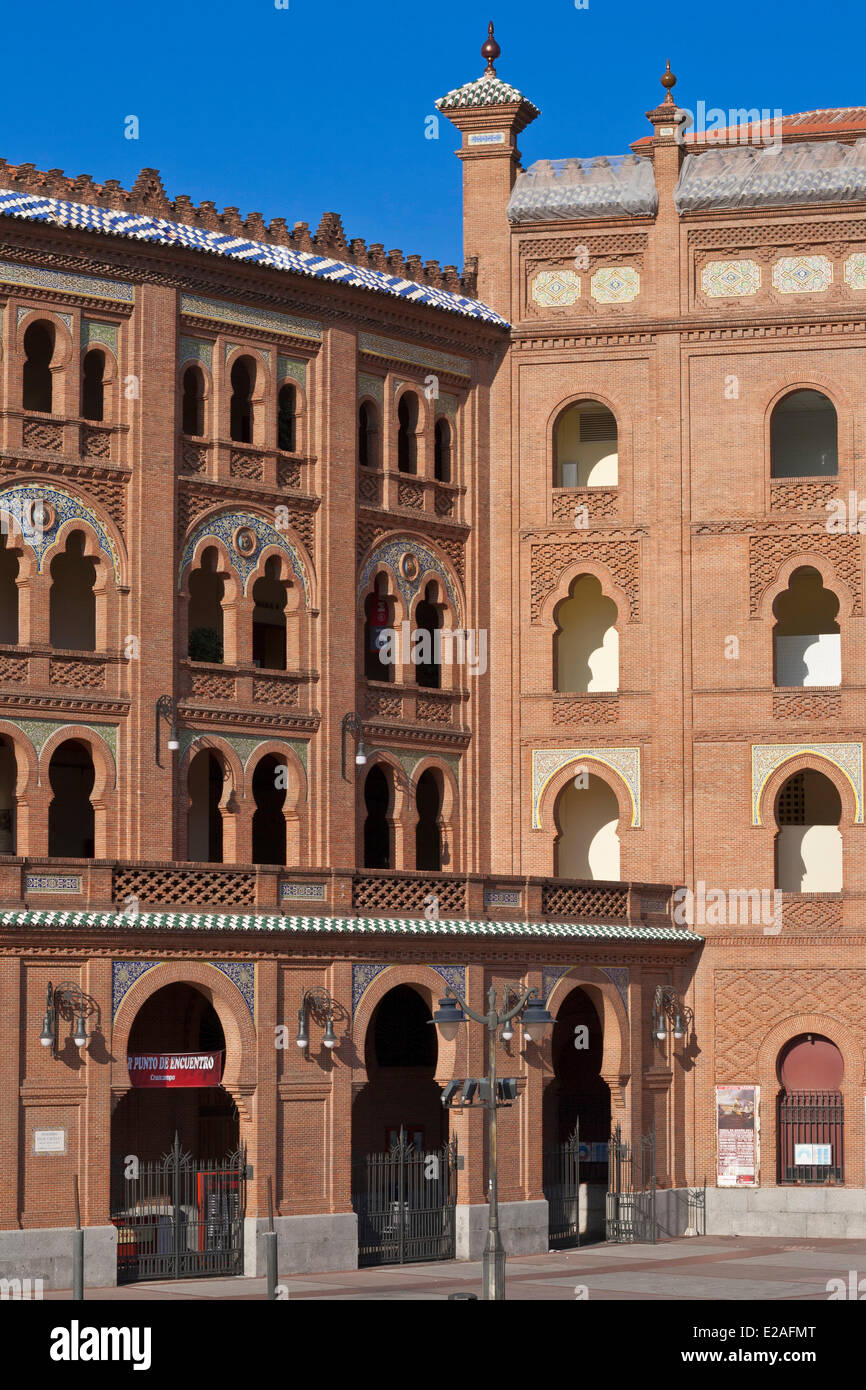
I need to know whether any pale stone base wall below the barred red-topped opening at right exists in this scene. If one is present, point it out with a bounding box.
[706,1187,866,1240]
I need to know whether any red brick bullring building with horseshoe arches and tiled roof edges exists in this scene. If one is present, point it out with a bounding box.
[0,29,866,1283]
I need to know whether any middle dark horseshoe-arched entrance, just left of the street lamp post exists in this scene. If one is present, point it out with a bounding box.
[352,984,457,1265]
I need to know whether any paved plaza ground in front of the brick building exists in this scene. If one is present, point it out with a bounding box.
[44,1236,866,1302]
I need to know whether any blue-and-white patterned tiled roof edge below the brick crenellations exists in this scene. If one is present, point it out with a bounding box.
[0,189,507,328]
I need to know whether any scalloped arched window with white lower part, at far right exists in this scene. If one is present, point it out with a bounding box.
[773,566,842,685]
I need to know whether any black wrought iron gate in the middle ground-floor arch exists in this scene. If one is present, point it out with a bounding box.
[352,1129,457,1265]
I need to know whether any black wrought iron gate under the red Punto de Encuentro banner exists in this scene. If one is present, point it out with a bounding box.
[111,1134,246,1283]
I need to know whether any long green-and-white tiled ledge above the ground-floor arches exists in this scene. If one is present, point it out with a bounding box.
[0,909,703,945]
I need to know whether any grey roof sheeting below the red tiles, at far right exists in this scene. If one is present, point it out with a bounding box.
[674,140,866,213]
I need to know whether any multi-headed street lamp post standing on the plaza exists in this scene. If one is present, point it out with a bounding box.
[432,984,553,1300]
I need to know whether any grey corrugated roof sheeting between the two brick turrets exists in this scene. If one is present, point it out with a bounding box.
[507,154,659,222]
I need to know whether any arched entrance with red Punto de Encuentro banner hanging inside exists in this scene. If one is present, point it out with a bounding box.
[111,981,246,1283]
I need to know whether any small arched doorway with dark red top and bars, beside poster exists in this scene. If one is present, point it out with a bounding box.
[777,1033,845,1187]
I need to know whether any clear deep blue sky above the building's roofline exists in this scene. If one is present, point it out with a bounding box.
[0,0,866,273]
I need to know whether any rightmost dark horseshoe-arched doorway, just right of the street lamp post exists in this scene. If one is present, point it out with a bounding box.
[542,986,610,1248]
